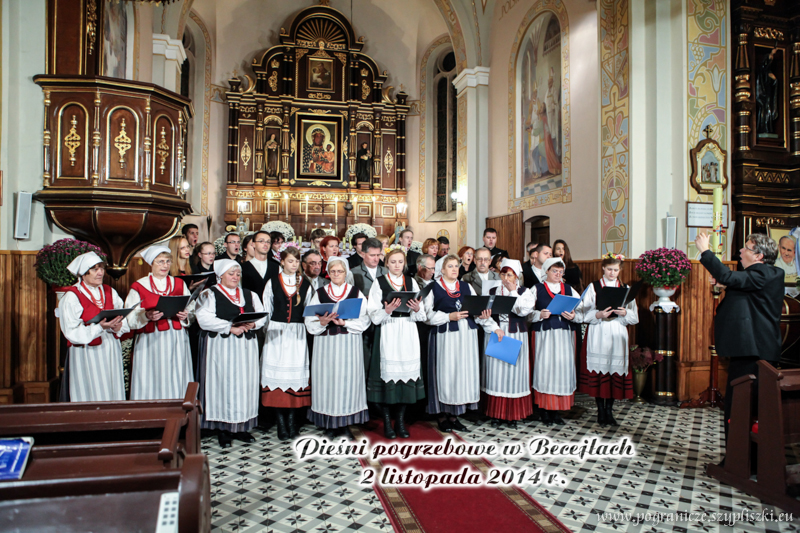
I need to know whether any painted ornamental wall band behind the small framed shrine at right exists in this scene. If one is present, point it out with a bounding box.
[686,0,729,258]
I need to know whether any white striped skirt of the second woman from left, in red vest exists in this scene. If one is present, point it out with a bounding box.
[131,328,194,400]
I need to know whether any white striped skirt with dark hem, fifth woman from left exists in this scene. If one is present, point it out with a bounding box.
[308,333,369,428]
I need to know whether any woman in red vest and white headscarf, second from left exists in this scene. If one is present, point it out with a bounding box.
[125,246,194,400]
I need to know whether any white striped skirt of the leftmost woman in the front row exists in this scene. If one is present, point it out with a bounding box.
[67,333,126,402]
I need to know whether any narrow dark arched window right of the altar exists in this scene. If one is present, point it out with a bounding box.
[433,50,458,213]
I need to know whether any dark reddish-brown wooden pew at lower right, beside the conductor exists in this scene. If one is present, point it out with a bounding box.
[706,361,800,514]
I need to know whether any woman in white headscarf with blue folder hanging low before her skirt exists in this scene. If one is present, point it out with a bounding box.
[481,258,536,428]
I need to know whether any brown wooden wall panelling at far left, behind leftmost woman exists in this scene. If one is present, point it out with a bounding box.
[0,250,58,404]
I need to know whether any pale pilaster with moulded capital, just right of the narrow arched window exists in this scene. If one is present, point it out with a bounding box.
[453,67,489,249]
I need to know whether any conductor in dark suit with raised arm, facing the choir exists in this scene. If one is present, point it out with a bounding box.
[694,233,783,437]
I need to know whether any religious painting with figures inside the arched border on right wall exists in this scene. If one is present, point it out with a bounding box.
[517,11,564,200]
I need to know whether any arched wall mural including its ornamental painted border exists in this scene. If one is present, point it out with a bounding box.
[509,0,572,211]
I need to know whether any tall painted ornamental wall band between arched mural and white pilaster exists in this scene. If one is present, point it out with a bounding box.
[597,0,630,255]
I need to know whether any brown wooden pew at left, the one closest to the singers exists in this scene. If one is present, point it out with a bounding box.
[0,383,200,461]
